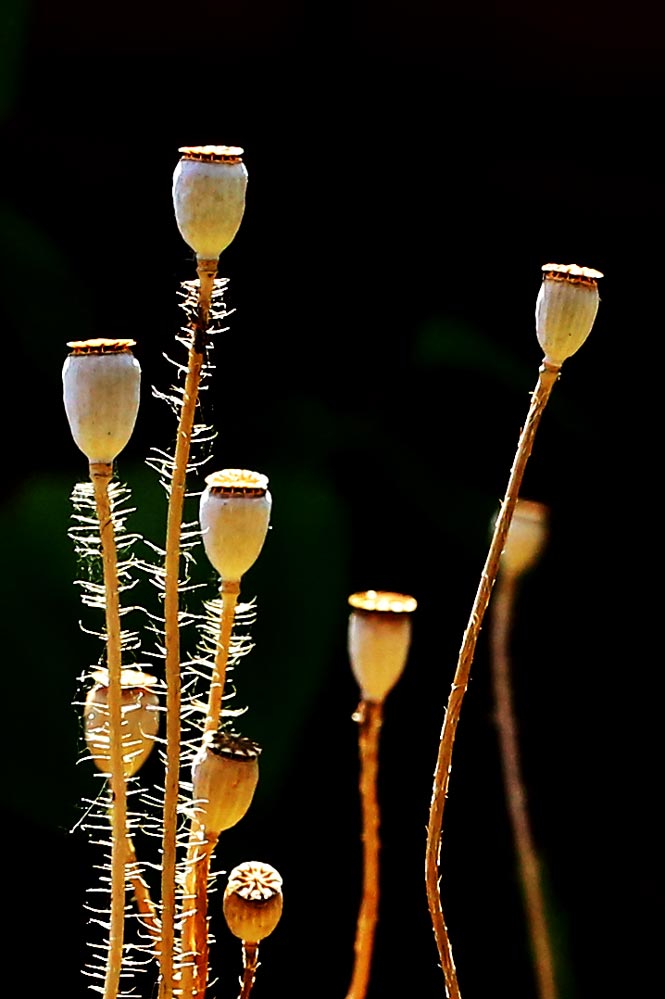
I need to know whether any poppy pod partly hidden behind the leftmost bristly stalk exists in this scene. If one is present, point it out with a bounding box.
[83,669,159,777]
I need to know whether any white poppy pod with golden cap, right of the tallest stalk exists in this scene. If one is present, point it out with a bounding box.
[199,468,272,582]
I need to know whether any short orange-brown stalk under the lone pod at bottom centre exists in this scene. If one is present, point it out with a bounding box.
[346,701,383,999]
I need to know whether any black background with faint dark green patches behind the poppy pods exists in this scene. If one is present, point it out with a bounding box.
[0,0,665,999]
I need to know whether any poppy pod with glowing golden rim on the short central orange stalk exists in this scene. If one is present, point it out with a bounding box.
[348,590,417,703]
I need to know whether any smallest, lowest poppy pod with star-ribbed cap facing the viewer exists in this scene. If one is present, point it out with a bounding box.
[223,860,283,944]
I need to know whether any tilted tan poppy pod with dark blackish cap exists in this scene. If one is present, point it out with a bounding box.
[192,732,261,840]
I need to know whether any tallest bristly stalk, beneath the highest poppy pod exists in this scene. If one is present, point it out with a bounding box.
[159,262,216,999]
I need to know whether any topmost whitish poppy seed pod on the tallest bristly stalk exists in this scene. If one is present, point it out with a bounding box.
[173,146,247,260]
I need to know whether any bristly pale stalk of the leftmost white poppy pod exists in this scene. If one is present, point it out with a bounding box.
[90,462,127,999]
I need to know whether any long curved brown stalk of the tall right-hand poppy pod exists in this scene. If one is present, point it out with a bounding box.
[425,361,559,999]
